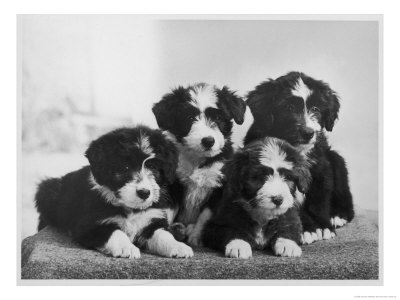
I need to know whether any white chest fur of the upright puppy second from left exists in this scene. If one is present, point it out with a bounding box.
[177,154,223,225]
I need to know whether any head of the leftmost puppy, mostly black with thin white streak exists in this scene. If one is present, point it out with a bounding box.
[85,126,178,209]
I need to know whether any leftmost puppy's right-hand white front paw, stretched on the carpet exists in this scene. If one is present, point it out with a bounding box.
[147,228,193,258]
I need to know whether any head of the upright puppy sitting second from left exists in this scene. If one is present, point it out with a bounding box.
[153,83,246,157]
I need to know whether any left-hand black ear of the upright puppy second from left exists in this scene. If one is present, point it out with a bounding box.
[152,87,189,130]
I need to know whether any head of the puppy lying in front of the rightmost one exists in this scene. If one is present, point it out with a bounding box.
[224,138,311,216]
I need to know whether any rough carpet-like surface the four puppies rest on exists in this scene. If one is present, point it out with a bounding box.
[21,207,379,280]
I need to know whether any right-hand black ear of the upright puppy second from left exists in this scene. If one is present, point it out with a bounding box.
[217,86,246,125]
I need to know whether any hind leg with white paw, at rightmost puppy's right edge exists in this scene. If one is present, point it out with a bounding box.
[328,150,354,228]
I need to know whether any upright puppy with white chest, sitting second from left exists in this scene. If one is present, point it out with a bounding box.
[153,83,246,246]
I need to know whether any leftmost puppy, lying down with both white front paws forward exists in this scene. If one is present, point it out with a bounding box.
[35,126,193,259]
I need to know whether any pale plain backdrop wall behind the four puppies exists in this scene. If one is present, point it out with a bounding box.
[18,15,379,238]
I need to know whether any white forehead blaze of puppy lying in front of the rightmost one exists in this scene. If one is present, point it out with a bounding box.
[260,138,293,170]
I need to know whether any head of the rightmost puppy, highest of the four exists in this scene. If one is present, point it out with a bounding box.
[247,72,340,146]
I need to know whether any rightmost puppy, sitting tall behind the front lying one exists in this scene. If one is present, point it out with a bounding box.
[245,72,354,243]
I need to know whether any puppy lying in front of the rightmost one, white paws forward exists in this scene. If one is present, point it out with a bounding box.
[202,138,311,259]
